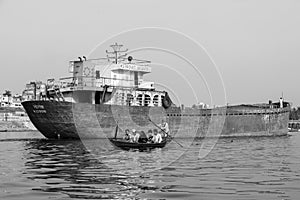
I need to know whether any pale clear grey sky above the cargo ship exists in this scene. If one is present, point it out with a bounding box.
[0,0,300,106]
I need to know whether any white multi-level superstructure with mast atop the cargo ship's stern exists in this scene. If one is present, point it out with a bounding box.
[46,43,170,107]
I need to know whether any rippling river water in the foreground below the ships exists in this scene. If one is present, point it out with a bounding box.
[0,133,300,200]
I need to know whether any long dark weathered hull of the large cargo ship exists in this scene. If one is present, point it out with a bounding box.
[22,101,290,139]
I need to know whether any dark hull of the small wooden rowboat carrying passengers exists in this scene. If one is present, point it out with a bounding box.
[109,138,167,150]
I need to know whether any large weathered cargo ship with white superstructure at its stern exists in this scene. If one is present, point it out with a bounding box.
[22,43,290,139]
